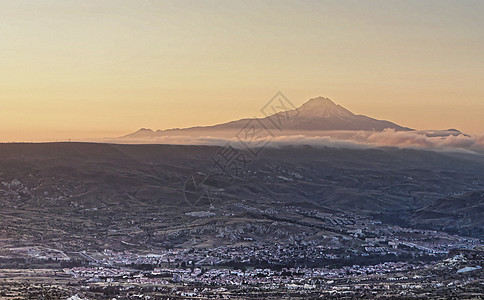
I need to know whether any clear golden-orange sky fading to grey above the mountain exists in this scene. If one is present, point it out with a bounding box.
[0,0,484,141]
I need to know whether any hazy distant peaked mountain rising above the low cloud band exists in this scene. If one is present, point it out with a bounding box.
[123,97,412,138]
